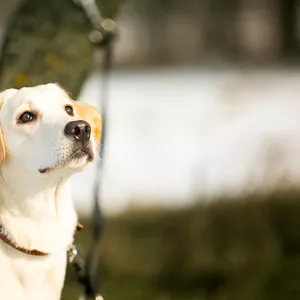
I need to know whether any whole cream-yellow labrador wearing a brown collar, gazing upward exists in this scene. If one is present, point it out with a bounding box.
[0,84,101,300]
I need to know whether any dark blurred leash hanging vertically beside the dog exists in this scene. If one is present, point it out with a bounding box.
[68,0,116,300]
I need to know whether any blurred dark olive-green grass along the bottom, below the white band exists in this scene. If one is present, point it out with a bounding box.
[63,192,300,300]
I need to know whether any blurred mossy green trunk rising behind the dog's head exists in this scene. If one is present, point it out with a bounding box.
[0,0,121,96]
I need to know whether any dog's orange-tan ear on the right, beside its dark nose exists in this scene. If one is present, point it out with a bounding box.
[74,101,102,146]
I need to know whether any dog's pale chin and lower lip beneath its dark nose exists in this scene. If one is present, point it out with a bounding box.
[39,150,94,174]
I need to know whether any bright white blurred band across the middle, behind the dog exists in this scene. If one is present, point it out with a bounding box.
[72,68,300,213]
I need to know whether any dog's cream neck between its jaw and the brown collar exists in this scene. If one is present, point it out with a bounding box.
[0,166,77,253]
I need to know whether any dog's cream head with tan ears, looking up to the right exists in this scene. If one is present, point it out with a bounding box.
[0,84,101,177]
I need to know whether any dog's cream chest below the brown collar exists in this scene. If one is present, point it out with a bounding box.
[0,249,66,300]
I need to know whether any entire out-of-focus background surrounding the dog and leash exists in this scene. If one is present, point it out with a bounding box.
[0,0,300,300]
